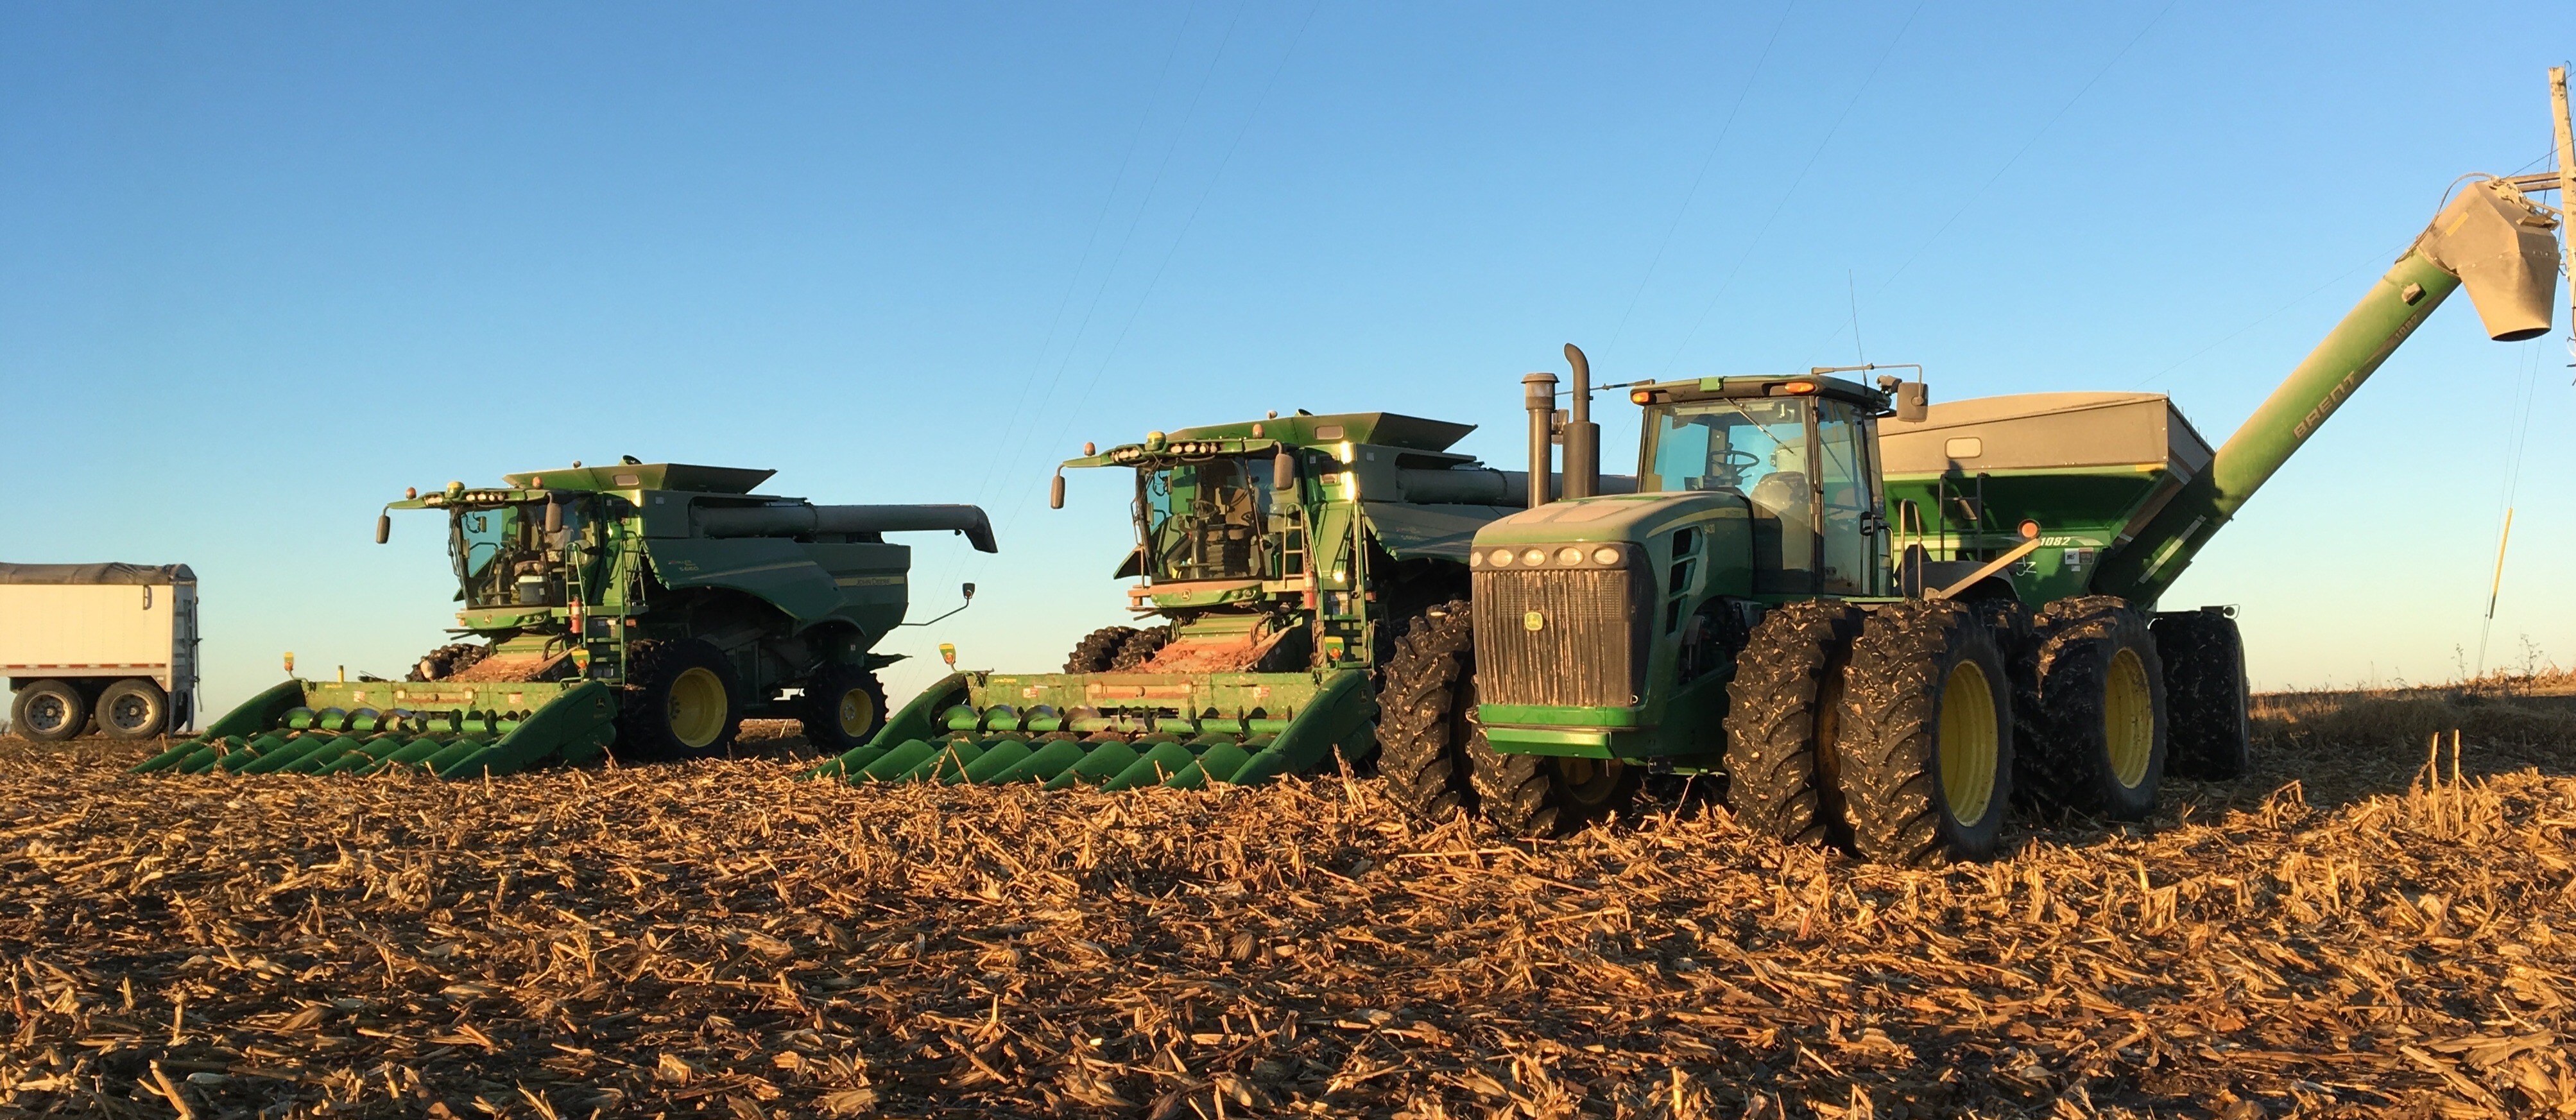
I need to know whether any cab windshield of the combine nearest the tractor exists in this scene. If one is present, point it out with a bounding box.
[1136,458,1275,582]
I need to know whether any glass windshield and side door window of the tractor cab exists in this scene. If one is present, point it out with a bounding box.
[1638,397,1847,592]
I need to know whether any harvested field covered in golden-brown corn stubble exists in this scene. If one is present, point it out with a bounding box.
[0,698,2576,1120]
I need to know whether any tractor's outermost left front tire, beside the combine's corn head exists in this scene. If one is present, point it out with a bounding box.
[1378,600,1484,822]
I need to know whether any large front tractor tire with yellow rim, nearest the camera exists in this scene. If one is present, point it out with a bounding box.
[1837,600,2012,865]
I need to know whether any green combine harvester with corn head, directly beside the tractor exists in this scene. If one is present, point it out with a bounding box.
[814,412,1627,788]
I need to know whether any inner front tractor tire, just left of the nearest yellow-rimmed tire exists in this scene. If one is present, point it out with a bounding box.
[1726,600,1860,845]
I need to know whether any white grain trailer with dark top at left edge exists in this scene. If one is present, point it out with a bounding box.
[0,564,196,741]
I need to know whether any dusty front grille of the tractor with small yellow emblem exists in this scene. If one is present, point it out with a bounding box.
[1473,569,1646,708]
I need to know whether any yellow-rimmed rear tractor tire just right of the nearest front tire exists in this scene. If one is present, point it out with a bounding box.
[2012,595,2169,822]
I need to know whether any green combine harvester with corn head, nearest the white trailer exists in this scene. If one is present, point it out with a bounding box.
[134,458,994,777]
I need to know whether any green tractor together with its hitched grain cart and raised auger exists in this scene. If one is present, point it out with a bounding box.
[1381,180,2555,863]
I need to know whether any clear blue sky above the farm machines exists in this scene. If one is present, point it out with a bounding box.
[0,0,2576,711]
